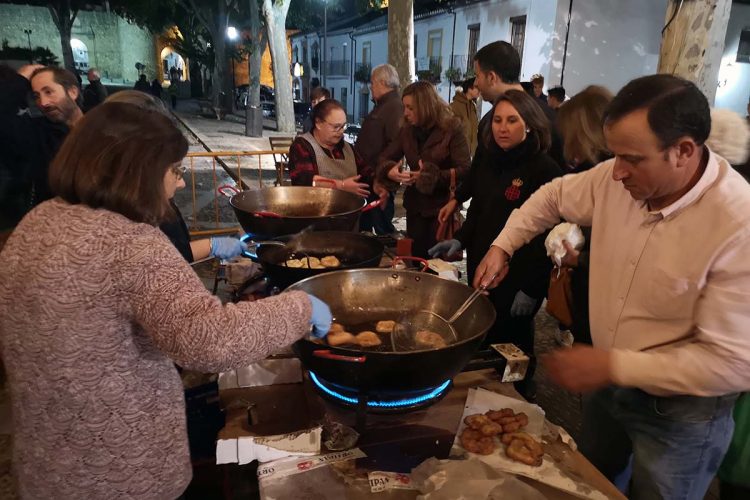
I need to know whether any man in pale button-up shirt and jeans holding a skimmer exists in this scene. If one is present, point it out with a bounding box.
[474,75,750,499]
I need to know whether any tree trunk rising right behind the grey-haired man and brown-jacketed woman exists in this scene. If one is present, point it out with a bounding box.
[388,0,414,88]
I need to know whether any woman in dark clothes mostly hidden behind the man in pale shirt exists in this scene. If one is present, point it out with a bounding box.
[557,85,612,344]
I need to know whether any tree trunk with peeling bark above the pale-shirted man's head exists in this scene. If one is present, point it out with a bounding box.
[658,0,732,103]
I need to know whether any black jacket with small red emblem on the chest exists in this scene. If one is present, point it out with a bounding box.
[456,137,562,299]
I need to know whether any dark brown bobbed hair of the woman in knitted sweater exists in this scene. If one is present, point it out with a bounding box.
[49,102,188,225]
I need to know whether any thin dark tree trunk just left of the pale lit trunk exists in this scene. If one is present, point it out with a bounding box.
[245,0,268,137]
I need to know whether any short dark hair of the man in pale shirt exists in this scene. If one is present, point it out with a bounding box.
[604,75,711,148]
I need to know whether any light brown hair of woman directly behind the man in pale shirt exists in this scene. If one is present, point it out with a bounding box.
[557,85,613,172]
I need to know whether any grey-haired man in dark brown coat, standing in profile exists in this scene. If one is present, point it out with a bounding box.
[354,64,404,234]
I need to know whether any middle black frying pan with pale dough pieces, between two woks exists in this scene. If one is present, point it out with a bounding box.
[248,231,384,289]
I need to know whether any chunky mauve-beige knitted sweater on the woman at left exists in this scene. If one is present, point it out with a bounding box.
[0,199,311,499]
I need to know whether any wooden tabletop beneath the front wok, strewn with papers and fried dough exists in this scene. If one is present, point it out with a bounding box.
[219,370,625,500]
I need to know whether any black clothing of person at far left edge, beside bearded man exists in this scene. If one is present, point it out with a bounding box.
[0,75,68,230]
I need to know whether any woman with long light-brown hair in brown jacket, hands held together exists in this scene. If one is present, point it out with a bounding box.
[378,82,471,258]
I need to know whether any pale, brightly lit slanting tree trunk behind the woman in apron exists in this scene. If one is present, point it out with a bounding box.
[263,0,297,134]
